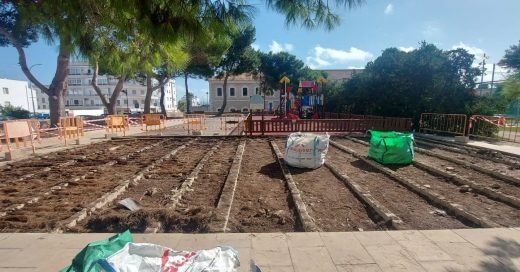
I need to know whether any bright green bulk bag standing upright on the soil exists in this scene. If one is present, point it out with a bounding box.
[368,130,413,165]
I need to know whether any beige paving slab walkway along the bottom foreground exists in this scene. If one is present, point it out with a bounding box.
[0,228,520,272]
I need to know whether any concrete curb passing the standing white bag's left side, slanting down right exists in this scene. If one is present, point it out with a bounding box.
[269,141,320,231]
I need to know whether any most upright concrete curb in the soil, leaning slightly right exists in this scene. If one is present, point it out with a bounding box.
[209,140,246,232]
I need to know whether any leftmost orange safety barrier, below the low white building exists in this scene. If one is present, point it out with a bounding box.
[0,120,35,154]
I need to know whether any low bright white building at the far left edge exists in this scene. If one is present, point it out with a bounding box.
[0,78,36,112]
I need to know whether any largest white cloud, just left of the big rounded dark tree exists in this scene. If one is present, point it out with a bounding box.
[306,45,373,69]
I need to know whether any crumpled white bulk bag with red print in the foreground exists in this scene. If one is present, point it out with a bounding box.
[101,243,240,272]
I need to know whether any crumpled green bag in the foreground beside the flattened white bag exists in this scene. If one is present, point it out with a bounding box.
[61,230,134,272]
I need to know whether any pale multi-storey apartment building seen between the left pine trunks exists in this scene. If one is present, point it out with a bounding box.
[37,58,177,115]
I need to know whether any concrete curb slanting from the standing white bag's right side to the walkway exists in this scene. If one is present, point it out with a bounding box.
[325,162,405,230]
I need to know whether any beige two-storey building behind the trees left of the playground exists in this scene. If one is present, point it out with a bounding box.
[208,74,280,112]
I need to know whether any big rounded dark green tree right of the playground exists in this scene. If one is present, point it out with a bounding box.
[325,42,480,118]
